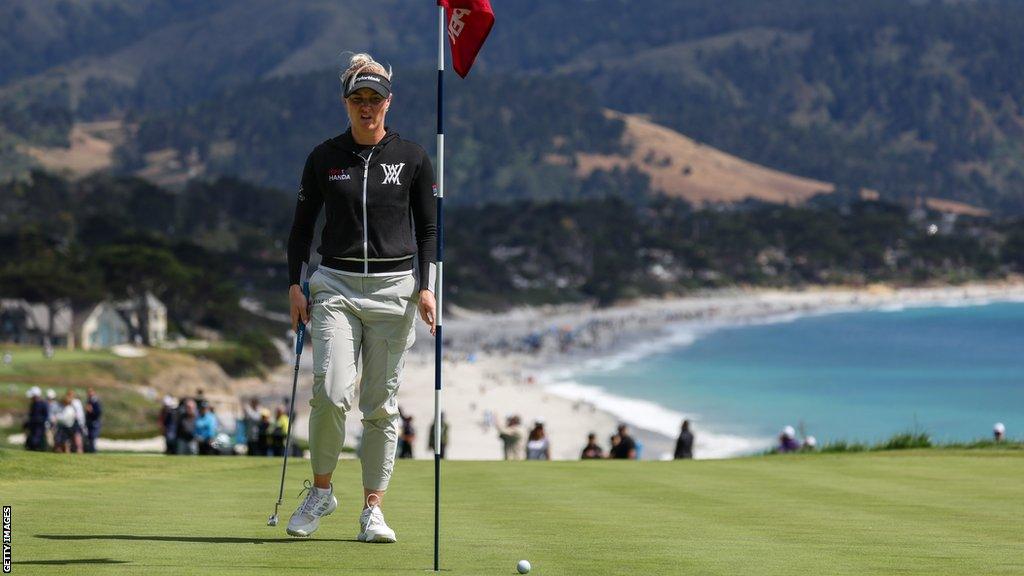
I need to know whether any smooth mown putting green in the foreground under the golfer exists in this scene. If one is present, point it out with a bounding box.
[0,450,1024,576]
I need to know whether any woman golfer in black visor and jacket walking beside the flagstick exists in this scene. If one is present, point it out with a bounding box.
[288,54,437,542]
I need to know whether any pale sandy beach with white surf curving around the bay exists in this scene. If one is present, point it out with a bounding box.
[402,282,1024,459]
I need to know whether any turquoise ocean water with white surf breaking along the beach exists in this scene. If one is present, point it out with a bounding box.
[546,302,1024,457]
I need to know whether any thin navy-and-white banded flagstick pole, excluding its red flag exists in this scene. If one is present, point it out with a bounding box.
[434,6,444,572]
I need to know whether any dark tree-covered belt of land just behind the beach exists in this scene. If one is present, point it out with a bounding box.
[0,170,1024,307]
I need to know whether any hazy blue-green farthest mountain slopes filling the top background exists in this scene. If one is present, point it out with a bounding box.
[0,0,1024,214]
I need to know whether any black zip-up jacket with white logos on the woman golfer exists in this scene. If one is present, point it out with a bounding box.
[288,129,437,289]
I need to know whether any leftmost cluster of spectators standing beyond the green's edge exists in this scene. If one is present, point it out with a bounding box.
[23,386,103,454]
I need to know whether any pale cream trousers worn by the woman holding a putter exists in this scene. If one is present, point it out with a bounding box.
[309,268,419,490]
